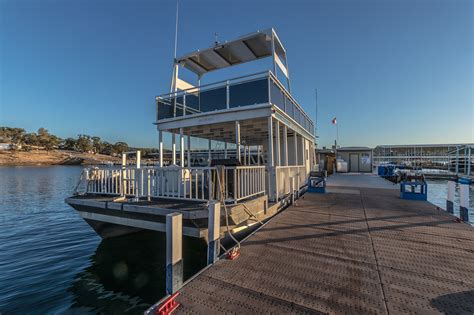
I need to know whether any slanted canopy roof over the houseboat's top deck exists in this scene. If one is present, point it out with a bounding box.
[177,28,286,76]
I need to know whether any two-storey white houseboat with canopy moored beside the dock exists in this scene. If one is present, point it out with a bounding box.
[66,28,315,239]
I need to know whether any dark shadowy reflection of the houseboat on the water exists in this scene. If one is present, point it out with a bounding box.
[68,232,206,313]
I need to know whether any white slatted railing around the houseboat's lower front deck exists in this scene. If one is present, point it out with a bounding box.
[76,166,265,203]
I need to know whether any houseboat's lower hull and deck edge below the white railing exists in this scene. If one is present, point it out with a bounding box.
[66,194,287,238]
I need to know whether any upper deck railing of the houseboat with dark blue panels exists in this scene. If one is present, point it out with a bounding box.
[156,71,314,135]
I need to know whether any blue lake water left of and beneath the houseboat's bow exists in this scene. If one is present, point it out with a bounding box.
[0,166,206,314]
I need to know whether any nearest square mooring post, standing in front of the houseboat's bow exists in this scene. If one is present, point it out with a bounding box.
[166,213,183,294]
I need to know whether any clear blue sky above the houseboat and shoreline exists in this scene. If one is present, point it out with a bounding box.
[0,0,474,147]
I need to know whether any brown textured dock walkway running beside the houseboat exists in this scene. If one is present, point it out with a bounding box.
[168,174,474,314]
